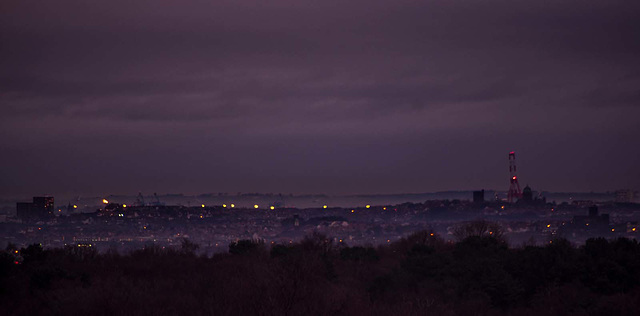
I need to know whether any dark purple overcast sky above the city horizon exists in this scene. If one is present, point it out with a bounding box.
[0,0,640,196]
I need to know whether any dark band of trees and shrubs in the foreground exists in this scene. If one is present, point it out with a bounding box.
[0,225,640,315]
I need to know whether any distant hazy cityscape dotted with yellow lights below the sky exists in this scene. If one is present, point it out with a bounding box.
[0,186,640,254]
